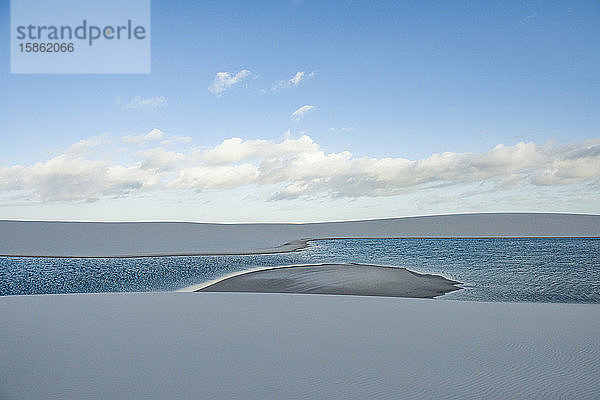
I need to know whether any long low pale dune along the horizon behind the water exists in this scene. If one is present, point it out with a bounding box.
[0,213,600,257]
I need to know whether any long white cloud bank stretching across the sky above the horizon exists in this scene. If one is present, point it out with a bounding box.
[0,130,600,201]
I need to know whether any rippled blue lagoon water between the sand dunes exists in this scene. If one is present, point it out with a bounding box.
[0,238,600,303]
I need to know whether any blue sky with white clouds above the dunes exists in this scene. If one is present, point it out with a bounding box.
[0,0,600,222]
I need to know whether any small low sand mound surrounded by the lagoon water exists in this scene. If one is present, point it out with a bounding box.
[195,263,462,298]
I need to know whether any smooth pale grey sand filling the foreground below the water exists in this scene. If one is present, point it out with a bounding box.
[0,293,600,400]
